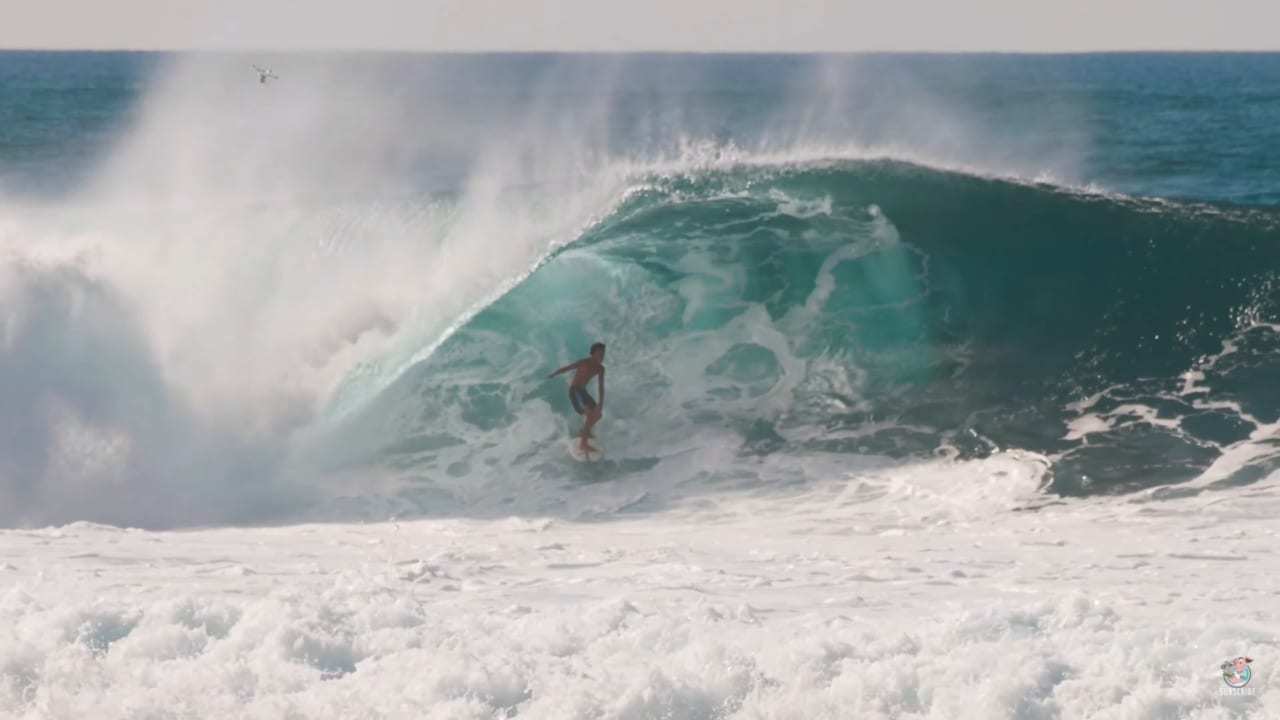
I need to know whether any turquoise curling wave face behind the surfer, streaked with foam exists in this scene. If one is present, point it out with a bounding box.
[332,161,1280,504]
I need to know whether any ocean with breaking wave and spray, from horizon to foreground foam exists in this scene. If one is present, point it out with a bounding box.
[0,53,1280,525]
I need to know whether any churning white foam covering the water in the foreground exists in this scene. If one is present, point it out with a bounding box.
[0,455,1280,720]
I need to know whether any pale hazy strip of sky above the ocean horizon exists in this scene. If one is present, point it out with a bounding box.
[0,0,1280,51]
